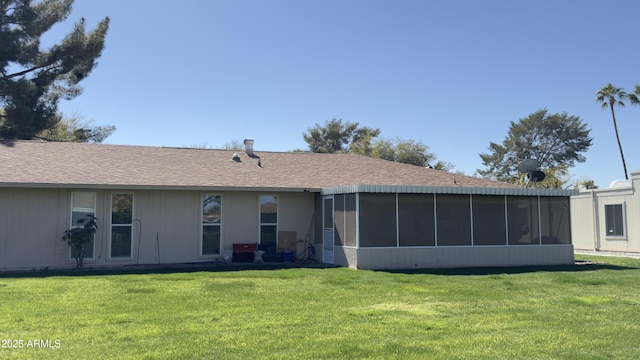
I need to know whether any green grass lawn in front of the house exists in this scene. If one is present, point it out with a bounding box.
[0,256,640,359]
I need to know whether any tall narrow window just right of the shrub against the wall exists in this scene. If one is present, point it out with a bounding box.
[111,194,133,258]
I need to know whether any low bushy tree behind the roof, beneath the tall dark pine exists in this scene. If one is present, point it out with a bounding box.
[34,117,116,144]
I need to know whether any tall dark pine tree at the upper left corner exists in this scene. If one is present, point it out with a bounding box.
[0,0,109,139]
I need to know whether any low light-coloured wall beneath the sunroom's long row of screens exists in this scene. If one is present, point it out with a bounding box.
[350,245,574,269]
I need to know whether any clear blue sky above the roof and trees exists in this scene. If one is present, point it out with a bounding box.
[49,0,640,187]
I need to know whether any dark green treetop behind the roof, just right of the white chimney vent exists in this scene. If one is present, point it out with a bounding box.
[302,119,380,154]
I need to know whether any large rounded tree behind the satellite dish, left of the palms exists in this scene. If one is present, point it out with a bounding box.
[477,109,593,184]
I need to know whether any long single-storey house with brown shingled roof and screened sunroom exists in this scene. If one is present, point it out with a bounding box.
[0,140,575,270]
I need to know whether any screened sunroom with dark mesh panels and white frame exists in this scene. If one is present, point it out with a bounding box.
[322,185,574,269]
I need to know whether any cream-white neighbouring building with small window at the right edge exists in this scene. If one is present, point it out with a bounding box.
[571,171,640,252]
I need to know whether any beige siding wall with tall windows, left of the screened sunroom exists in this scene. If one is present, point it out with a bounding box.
[0,188,315,270]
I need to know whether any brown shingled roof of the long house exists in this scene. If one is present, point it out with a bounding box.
[0,140,515,191]
